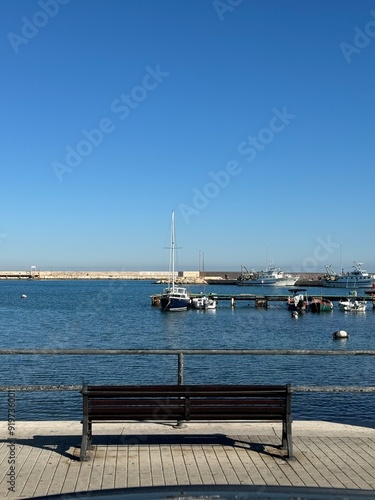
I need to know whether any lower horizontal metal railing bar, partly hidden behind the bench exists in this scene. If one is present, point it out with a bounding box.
[0,384,375,392]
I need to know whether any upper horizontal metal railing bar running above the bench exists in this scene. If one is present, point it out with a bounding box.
[0,349,375,356]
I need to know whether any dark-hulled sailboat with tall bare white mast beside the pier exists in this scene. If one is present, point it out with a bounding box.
[160,211,191,311]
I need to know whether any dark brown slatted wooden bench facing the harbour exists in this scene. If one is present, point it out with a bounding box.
[80,385,293,460]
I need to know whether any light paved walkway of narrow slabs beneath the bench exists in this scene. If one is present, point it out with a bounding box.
[0,421,375,499]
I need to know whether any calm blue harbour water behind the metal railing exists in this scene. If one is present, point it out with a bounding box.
[0,281,375,427]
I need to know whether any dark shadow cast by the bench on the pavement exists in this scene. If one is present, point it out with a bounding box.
[0,433,283,461]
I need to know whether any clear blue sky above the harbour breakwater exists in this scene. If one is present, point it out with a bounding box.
[0,0,375,272]
